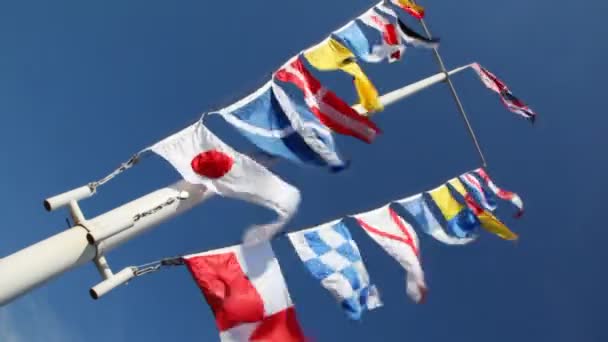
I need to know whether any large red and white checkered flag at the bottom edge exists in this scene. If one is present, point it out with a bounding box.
[184,242,307,342]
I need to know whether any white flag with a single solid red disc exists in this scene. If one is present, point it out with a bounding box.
[149,120,300,244]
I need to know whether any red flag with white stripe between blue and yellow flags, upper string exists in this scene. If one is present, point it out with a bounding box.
[274,56,380,143]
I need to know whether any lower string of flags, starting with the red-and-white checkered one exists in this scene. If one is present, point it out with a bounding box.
[127,168,523,342]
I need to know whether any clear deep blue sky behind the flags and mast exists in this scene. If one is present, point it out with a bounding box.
[0,0,608,342]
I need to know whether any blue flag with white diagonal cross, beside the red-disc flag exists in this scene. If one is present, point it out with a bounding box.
[214,81,347,170]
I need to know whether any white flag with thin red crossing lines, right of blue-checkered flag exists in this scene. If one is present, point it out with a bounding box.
[354,204,427,303]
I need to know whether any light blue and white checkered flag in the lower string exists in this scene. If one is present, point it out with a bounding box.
[288,220,382,320]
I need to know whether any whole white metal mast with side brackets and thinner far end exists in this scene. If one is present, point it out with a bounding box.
[0,65,469,306]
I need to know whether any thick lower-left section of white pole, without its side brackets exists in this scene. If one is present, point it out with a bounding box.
[0,181,211,306]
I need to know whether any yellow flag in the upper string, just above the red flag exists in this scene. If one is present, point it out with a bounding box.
[304,37,384,112]
